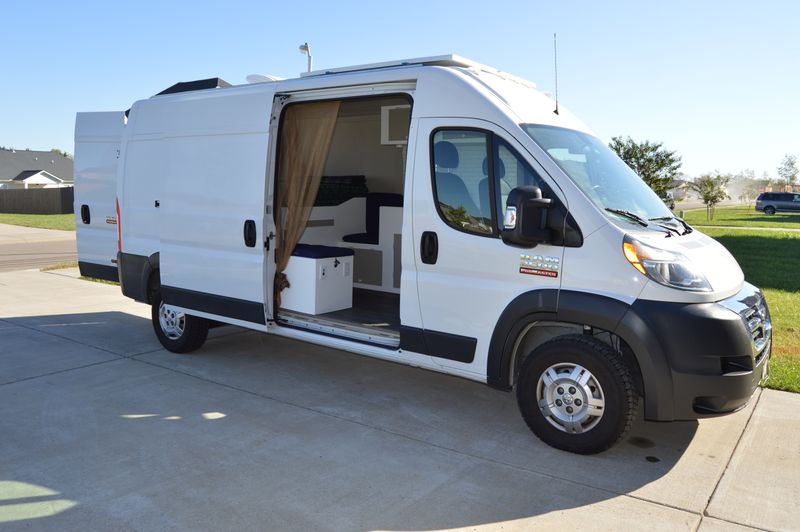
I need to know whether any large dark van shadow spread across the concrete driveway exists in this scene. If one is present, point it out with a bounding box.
[0,312,708,530]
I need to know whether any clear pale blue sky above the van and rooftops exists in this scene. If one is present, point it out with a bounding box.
[0,0,800,178]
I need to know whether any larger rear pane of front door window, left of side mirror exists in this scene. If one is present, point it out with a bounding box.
[432,129,496,236]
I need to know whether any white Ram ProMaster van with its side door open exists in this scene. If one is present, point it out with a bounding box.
[75,56,771,453]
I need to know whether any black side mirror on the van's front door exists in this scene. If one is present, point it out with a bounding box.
[500,187,553,248]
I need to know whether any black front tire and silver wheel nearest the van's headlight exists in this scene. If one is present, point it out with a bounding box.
[517,334,639,454]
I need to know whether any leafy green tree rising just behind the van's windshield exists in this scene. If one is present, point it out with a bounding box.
[608,137,681,196]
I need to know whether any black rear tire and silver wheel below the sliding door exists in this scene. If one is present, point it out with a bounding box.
[150,292,208,353]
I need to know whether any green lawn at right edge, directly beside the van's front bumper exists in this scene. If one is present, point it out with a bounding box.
[703,228,800,393]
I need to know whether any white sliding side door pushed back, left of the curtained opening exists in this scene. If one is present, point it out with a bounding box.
[157,85,274,330]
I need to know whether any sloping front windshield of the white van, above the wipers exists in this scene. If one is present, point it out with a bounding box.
[521,124,673,225]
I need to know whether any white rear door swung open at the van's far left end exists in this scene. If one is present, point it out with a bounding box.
[74,111,125,281]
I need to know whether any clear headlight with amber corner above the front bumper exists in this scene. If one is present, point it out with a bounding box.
[622,235,711,292]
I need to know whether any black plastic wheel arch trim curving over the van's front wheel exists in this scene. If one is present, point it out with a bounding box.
[486,289,673,420]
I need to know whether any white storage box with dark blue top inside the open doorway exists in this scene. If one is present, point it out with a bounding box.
[281,244,353,314]
